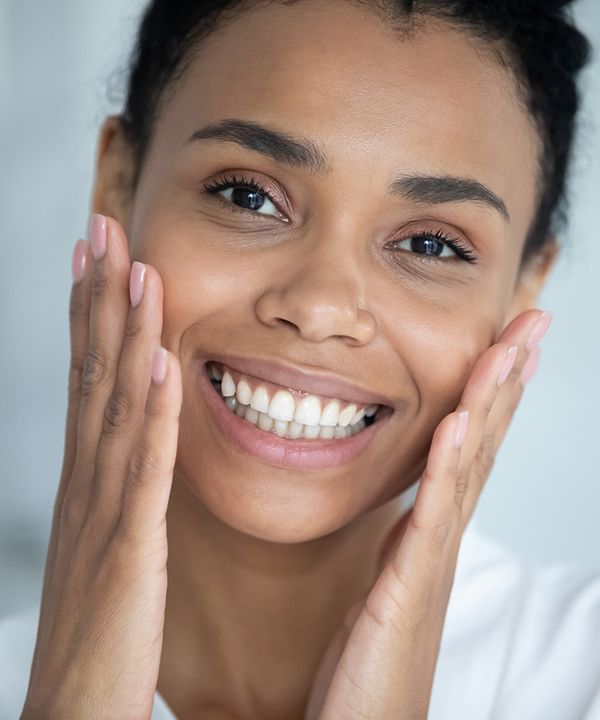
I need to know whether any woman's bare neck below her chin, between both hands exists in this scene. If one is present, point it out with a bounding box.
[158,476,414,720]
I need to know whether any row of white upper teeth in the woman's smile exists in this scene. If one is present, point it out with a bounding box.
[209,364,379,427]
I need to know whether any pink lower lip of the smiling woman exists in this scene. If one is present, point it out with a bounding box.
[200,365,391,470]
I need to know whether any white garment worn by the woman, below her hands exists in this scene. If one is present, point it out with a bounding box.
[0,520,600,720]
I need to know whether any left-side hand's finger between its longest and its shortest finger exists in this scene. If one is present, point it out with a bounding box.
[92,262,163,522]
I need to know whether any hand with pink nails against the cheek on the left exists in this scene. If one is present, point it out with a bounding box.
[21,215,182,720]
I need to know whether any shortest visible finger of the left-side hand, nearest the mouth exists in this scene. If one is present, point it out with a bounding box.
[119,347,182,541]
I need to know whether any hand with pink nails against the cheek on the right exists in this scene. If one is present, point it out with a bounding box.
[305,310,551,720]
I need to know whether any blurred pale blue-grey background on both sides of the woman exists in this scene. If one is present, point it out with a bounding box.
[0,0,600,617]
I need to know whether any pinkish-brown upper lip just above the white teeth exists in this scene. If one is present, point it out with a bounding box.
[207,355,392,405]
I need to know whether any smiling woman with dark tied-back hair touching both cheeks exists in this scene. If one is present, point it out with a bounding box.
[2,0,600,720]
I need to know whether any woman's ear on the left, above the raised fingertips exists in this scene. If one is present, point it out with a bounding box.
[91,115,134,233]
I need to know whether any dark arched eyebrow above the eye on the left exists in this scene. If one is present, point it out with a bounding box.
[188,120,327,174]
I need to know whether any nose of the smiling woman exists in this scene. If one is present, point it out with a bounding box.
[255,243,376,346]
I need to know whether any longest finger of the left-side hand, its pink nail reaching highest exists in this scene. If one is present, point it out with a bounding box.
[63,215,130,525]
